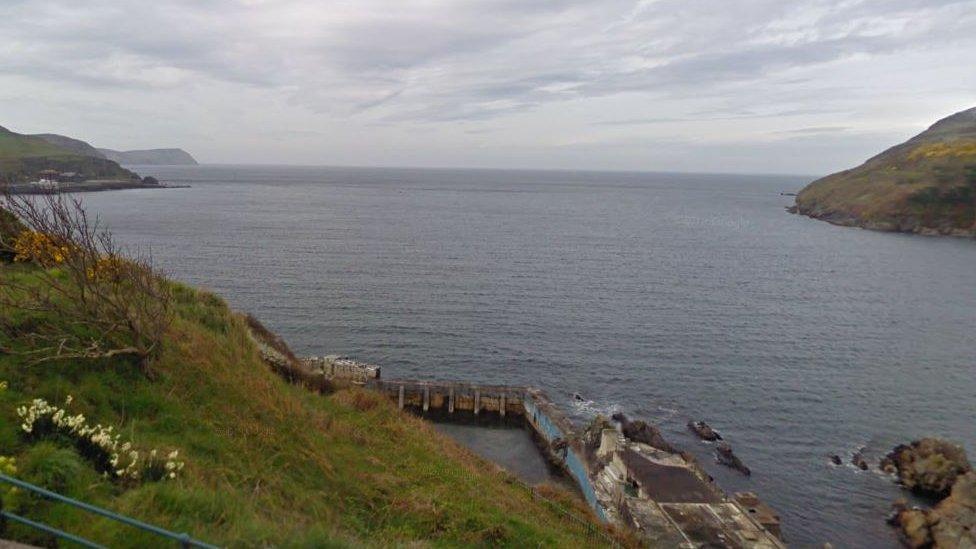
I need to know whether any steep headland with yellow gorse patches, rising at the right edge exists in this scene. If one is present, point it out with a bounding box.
[792,108,976,236]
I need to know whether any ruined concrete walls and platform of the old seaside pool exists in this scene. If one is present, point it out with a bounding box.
[304,356,785,549]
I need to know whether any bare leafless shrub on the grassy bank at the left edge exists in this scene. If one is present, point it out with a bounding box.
[0,194,170,373]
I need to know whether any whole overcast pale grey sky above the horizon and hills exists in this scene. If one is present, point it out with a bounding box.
[0,0,976,175]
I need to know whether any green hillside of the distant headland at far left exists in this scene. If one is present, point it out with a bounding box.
[0,127,139,183]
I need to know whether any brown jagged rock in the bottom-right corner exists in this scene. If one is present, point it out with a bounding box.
[891,472,976,548]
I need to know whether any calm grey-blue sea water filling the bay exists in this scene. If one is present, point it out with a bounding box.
[84,166,976,547]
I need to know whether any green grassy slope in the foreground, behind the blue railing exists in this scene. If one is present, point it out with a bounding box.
[0,256,620,547]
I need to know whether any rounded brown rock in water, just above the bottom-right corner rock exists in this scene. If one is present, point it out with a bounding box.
[881,438,972,497]
